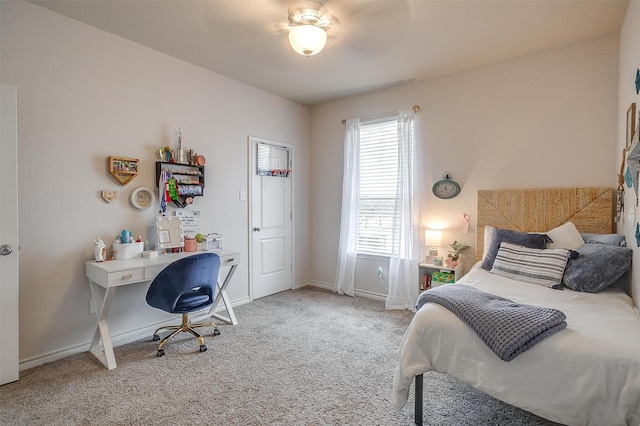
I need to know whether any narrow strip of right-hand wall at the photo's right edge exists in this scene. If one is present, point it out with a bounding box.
[616,1,640,306]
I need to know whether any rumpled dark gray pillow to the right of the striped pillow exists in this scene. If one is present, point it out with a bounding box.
[562,243,633,293]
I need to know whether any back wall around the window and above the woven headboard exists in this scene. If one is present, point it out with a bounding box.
[309,34,620,294]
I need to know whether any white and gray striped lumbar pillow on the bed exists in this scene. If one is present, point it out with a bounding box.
[491,242,570,288]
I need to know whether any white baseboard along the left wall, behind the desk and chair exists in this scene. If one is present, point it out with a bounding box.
[19,297,250,371]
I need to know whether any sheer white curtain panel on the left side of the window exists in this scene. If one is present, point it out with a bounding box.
[333,118,360,296]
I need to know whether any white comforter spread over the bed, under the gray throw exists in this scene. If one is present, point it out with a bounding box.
[393,265,640,425]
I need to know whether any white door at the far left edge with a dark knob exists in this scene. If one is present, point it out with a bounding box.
[0,84,19,385]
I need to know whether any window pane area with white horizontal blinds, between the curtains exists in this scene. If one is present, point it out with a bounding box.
[358,115,408,256]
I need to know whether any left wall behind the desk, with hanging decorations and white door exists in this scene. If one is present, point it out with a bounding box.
[0,1,309,365]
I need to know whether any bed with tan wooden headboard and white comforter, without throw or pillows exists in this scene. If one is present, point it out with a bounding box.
[393,188,640,425]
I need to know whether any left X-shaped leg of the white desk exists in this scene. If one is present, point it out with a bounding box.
[89,280,116,370]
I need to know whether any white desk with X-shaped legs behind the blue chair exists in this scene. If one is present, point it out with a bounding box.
[85,249,240,370]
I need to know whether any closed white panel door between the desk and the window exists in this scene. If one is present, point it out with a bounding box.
[249,137,293,299]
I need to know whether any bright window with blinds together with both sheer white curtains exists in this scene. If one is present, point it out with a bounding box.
[334,111,419,298]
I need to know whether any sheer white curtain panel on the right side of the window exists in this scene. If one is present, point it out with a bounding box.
[385,111,420,310]
